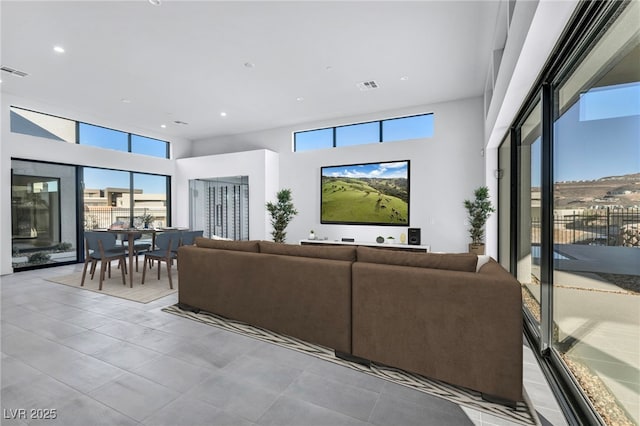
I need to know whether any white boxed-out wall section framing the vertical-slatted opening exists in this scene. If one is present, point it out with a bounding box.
[174,149,278,240]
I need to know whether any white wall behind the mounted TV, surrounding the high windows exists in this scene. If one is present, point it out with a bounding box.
[190,97,484,252]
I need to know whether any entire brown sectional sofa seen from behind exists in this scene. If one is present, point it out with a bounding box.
[178,238,523,403]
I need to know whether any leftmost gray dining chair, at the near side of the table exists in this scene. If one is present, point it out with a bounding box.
[80,231,127,290]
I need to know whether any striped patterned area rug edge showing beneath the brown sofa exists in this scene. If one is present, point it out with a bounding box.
[162,305,540,425]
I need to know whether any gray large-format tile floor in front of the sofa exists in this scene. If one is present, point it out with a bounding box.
[0,265,566,426]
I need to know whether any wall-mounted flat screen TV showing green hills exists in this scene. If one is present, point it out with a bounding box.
[320,160,410,226]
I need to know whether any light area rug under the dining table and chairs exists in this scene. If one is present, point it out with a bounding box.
[47,267,178,303]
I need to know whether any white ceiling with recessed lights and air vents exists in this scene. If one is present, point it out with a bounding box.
[0,0,498,140]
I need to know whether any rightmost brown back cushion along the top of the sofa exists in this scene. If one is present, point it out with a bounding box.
[358,246,478,272]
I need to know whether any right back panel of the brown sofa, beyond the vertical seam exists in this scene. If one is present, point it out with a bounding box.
[352,262,522,401]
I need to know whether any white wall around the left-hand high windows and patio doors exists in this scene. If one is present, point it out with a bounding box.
[0,94,191,275]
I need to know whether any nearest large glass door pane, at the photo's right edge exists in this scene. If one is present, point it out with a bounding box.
[552,2,640,425]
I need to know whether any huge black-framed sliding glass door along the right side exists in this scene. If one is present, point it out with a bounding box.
[499,2,640,425]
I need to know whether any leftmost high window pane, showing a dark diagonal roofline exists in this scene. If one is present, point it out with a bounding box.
[10,107,76,143]
